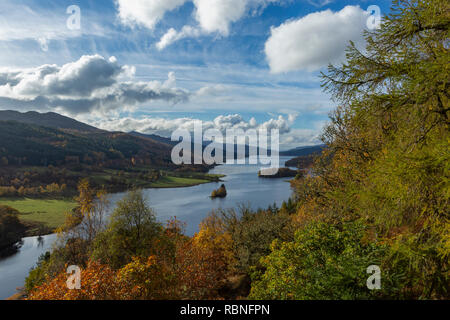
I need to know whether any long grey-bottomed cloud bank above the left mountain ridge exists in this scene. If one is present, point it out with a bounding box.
[0,55,188,114]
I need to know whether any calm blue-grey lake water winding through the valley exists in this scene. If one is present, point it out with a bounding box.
[0,157,291,299]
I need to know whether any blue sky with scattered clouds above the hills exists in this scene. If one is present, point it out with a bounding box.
[0,0,391,149]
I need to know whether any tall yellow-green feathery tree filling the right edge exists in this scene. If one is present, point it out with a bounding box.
[320,0,450,298]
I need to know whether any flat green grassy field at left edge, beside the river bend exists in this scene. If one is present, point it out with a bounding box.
[0,198,76,229]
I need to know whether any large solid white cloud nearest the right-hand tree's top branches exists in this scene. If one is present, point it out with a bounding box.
[265,6,368,73]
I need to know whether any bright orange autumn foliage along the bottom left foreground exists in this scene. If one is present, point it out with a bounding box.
[29,215,236,300]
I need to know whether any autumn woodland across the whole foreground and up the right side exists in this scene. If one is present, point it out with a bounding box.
[10,0,450,299]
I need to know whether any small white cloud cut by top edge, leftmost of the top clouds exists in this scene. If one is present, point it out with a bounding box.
[116,0,187,30]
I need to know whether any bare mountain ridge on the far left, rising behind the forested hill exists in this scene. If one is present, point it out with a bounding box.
[0,110,103,132]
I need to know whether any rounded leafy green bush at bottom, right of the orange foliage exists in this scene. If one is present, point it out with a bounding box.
[250,222,390,300]
